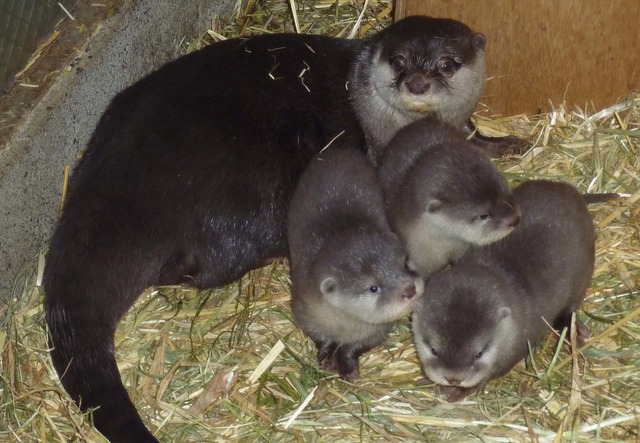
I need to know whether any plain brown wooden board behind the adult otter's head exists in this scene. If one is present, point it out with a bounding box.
[395,0,640,115]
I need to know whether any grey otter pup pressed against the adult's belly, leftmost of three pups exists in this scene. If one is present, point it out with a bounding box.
[288,146,423,381]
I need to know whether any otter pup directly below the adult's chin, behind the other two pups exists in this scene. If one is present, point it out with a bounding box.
[378,119,520,277]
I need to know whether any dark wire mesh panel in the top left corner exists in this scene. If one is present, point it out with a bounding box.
[0,0,77,90]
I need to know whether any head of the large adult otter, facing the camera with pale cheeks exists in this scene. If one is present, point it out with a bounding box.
[371,17,486,128]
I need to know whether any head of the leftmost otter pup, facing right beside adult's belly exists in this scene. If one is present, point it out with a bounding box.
[312,228,424,324]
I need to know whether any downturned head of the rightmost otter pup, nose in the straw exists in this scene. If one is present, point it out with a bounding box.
[412,266,518,388]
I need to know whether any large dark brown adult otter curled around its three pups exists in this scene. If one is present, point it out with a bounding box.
[44,17,510,442]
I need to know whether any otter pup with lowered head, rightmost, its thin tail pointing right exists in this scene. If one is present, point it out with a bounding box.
[412,181,595,401]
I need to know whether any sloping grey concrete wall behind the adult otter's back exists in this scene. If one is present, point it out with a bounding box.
[0,0,236,307]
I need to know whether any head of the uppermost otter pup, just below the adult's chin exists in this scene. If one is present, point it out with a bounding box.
[410,143,521,245]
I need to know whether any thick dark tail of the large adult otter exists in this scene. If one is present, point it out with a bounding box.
[44,253,157,442]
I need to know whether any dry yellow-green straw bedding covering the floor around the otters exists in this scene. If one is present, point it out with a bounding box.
[0,1,640,442]
